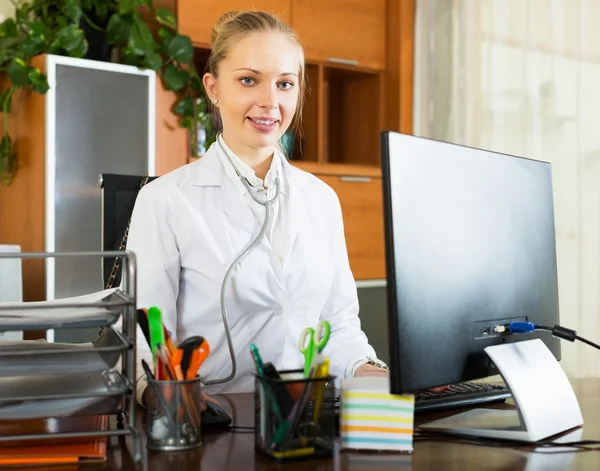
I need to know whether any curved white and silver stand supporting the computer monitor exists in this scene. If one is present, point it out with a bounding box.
[420,339,583,442]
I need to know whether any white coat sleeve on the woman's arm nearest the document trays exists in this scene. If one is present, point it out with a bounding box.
[127,186,180,404]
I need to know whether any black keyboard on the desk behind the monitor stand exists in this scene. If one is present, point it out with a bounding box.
[415,382,511,413]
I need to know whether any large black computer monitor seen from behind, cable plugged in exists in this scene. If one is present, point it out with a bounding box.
[381,132,560,394]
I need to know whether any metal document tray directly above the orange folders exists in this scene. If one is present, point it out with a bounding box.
[0,370,128,420]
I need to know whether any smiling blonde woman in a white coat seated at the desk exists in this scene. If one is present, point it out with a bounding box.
[127,12,387,408]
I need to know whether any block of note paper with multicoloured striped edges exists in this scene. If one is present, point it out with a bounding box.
[340,377,415,452]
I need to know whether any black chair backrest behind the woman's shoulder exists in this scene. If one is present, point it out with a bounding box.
[100,173,158,287]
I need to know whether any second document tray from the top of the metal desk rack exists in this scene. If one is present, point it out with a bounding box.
[0,327,131,378]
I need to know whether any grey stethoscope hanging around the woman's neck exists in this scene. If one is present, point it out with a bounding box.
[202,132,281,386]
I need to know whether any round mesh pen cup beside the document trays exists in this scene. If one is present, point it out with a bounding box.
[146,377,202,451]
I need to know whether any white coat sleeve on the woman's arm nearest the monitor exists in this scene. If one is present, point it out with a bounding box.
[321,190,375,379]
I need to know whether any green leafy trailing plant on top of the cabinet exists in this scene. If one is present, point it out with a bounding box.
[0,0,214,185]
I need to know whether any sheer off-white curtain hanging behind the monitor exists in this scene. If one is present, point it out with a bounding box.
[414,0,600,377]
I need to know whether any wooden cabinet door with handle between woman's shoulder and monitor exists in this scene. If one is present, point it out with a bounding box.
[294,162,385,281]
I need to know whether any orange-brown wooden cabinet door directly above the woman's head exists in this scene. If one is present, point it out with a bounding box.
[177,0,292,47]
